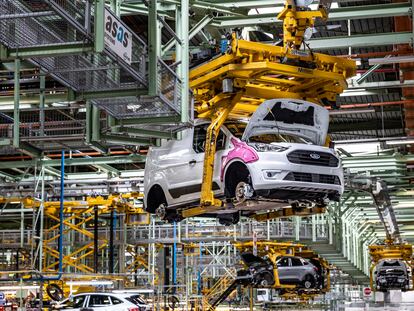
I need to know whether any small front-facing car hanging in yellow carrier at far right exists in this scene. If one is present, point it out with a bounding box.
[374,259,410,291]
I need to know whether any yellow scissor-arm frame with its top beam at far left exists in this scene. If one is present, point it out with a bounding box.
[0,192,149,273]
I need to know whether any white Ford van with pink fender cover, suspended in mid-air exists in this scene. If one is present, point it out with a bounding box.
[144,99,344,224]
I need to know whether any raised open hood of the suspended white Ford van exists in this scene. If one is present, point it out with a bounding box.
[242,99,329,145]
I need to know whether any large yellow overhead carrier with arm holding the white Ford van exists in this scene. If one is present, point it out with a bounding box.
[181,1,356,218]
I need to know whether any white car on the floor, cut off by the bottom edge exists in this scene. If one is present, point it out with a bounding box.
[53,293,150,311]
